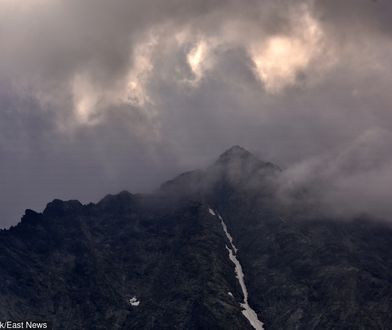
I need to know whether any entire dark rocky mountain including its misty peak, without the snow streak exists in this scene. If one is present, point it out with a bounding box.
[0,146,392,329]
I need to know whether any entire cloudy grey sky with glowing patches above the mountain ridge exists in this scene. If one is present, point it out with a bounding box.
[0,0,392,227]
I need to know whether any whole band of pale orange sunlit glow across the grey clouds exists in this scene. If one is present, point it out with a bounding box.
[0,0,334,126]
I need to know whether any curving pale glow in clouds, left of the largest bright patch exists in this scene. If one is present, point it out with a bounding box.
[72,27,216,125]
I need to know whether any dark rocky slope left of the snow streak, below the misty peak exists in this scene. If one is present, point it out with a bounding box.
[0,193,250,329]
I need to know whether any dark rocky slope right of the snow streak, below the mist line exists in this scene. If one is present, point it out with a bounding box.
[214,202,392,329]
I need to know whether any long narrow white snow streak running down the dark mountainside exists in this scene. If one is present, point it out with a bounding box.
[209,209,264,330]
